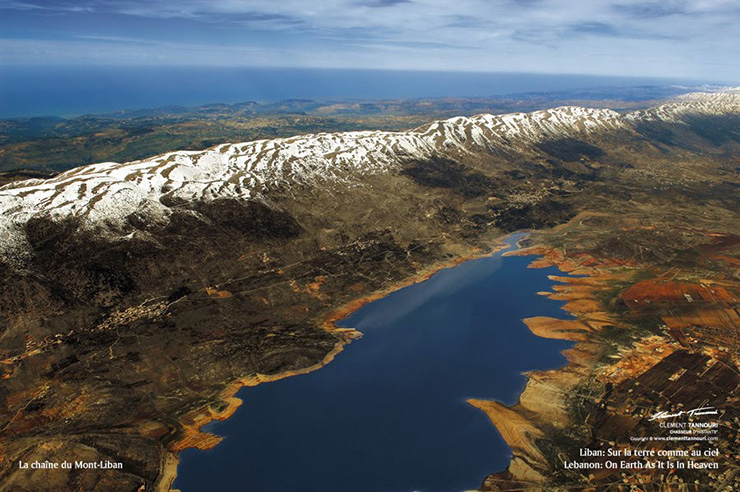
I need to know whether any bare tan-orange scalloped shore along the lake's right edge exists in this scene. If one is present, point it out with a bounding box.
[470,244,619,490]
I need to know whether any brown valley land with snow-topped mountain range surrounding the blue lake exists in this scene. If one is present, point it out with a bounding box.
[0,90,740,490]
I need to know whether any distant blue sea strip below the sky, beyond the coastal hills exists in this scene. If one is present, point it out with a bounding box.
[0,66,696,118]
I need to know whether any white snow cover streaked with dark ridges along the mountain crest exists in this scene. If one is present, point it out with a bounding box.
[0,90,740,264]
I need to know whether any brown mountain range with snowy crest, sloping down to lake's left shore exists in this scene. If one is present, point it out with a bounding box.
[0,91,740,490]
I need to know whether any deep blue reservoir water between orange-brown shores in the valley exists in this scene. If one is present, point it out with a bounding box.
[175,235,571,492]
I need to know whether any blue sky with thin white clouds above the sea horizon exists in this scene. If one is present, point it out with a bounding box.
[0,0,740,83]
